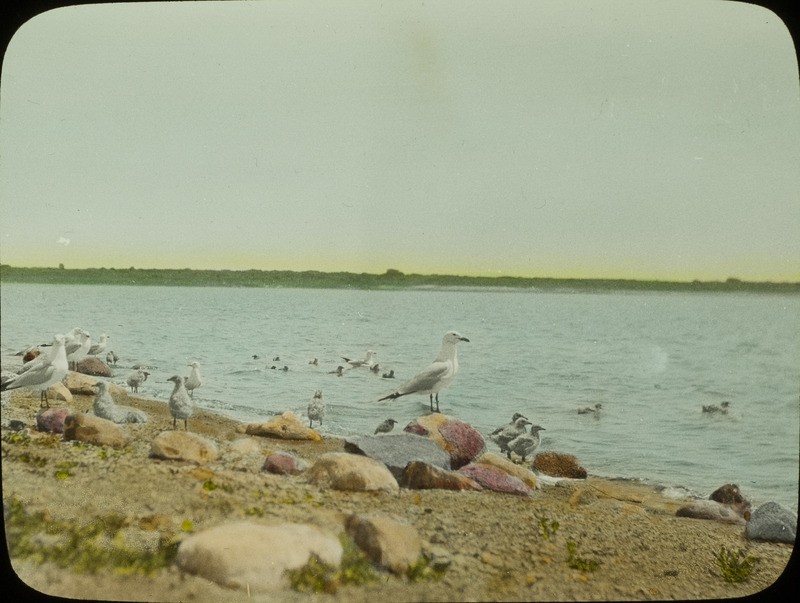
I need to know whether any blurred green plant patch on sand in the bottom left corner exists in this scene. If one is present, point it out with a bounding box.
[3,498,178,575]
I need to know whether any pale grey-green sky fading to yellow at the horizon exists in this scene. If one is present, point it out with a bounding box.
[0,0,800,281]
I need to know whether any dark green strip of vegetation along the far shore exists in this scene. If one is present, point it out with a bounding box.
[0,264,800,293]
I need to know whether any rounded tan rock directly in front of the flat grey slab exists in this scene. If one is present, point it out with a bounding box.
[308,452,400,494]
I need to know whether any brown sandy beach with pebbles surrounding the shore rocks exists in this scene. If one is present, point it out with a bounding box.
[2,392,793,601]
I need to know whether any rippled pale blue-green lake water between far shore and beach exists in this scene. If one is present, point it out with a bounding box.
[0,284,800,511]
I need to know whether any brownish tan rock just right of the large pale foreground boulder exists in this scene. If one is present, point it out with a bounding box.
[345,514,422,574]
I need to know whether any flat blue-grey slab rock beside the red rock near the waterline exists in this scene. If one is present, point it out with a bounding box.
[344,433,450,480]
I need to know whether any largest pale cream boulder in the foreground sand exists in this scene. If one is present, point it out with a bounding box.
[176,522,342,590]
